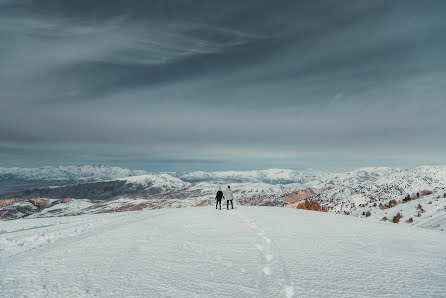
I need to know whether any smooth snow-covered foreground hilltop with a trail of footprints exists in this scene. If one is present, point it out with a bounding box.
[0,206,446,297]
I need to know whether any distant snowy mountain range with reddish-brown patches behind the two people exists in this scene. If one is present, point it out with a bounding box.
[0,166,446,230]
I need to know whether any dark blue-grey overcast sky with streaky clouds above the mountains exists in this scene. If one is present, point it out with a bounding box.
[0,0,446,171]
